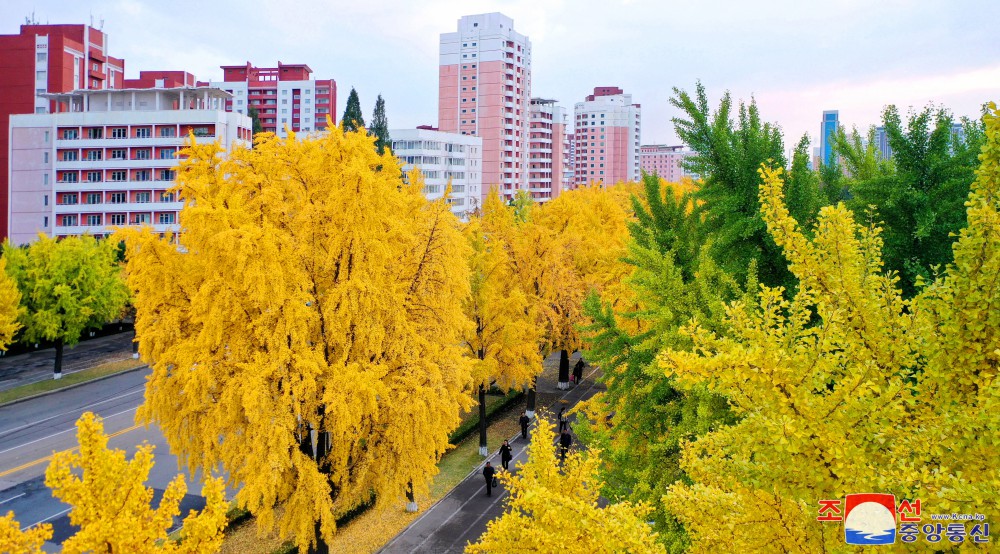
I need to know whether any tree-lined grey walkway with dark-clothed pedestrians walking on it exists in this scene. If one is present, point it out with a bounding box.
[379,353,604,554]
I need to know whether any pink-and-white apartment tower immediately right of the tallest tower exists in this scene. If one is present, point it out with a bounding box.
[528,98,572,202]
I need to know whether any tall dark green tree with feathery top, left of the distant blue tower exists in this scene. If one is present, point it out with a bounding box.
[670,82,791,286]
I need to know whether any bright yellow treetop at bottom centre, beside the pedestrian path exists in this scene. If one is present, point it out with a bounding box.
[465,418,664,553]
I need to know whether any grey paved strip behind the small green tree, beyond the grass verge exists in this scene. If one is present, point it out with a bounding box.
[0,332,132,391]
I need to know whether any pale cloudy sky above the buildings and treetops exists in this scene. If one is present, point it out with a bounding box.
[0,0,1000,152]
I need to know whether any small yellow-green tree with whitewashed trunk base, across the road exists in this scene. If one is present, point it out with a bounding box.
[4,235,128,379]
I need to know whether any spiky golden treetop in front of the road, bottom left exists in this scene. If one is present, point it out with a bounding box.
[45,412,228,554]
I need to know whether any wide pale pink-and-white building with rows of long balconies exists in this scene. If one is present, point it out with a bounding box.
[4,87,251,244]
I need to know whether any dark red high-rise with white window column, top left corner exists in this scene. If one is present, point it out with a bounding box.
[0,25,125,240]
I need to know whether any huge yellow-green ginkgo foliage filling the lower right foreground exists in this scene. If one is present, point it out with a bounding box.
[660,102,1000,552]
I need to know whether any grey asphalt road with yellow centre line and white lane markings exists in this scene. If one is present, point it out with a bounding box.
[0,368,204,549]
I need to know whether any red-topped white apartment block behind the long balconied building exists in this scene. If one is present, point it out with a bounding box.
[208,62,337,137]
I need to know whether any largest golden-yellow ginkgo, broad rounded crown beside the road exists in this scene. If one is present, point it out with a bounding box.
[120,130,471,548]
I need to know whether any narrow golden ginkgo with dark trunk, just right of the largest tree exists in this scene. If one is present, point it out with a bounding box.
[462,191,542,456]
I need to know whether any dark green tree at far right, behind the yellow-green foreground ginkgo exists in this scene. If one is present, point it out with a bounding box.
[837,102,984,297]
